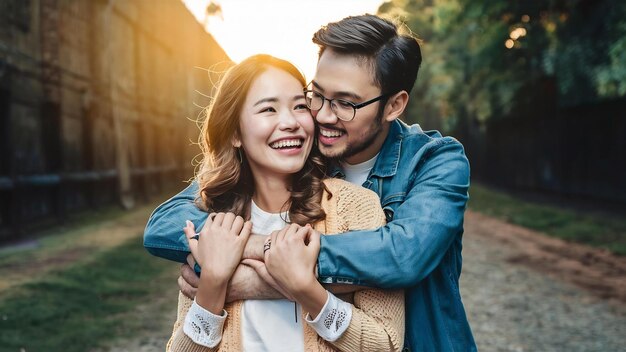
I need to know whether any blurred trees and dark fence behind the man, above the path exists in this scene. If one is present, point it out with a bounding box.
[380,0,626,203]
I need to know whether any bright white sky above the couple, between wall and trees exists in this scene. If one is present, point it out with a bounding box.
[182,0,384,79]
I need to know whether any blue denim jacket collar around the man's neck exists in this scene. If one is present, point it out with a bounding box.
[329,120,404,178]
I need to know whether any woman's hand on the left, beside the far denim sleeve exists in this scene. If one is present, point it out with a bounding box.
[183,213,252,283]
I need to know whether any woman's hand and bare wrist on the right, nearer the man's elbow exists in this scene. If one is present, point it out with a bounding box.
[265,224,328,317]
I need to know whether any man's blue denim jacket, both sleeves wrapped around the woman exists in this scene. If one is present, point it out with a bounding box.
[144,121,476,351]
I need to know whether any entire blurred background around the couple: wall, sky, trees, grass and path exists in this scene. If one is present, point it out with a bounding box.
[0,0,626,351]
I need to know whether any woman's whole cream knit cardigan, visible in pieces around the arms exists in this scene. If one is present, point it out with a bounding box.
[167,179,404,352]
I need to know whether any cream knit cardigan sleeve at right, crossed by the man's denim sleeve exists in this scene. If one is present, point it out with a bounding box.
[316,181,404,351]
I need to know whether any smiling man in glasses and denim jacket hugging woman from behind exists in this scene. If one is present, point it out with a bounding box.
[145,15,476,351]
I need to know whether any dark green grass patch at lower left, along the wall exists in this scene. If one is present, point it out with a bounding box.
[0,236,175,352]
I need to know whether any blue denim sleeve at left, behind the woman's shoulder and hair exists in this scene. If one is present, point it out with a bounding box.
[143,181,207,263]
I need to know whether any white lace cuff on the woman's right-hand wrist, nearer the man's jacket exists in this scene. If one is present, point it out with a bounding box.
[305,292,352,342]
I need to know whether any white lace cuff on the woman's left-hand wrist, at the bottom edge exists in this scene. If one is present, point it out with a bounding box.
[183,299,228,348]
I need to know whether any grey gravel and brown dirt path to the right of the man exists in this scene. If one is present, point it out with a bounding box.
[461,212,626,351]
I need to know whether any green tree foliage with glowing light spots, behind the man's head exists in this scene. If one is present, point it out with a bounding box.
[379,0,626,132]
